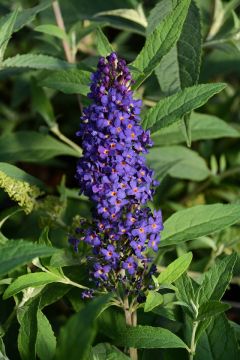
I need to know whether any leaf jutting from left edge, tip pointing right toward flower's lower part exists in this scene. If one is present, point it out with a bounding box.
[0,240,57,276]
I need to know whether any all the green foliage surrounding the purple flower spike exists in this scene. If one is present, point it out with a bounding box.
[0,0,240,360]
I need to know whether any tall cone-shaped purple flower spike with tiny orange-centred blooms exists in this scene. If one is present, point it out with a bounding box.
[73,53,163,297]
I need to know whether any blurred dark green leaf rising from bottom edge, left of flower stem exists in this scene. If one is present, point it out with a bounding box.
[56,295,110,360]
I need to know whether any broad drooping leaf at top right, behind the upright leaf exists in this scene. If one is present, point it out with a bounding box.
[156,0,202,95]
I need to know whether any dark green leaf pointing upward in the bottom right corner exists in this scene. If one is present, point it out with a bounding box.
[194,315,240,360]
